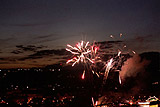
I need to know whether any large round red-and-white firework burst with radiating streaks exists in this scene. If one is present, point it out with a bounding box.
[66,41,99,79]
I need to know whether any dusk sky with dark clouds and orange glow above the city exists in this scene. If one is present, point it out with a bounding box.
[0,0,160,68]
